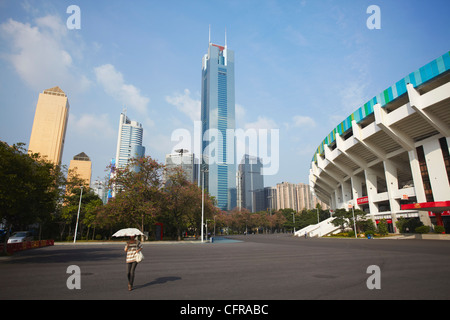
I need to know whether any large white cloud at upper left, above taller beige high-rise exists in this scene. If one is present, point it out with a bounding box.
[0,15,90,92]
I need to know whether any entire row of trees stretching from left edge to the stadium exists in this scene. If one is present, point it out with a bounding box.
[0,141,329,248]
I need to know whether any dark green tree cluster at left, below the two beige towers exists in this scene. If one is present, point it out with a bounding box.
[0,141,102,252]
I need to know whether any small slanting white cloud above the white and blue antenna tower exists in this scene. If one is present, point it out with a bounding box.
[94,64,150,115]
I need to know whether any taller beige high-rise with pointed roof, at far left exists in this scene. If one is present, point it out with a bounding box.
[28,87,70,165]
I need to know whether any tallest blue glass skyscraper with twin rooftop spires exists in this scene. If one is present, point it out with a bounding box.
[200,31,236,210]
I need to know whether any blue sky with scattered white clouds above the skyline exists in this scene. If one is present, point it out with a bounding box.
[0,0,450,186]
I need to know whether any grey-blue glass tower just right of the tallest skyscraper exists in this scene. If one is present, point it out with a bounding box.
[237,154,266,212]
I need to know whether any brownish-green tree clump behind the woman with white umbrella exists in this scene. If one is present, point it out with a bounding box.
[95,157,217,240]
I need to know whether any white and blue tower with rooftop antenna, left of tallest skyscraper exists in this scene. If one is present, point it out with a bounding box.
[115,113,145,168]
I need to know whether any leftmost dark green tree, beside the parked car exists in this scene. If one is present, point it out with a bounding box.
[0,141,65,252]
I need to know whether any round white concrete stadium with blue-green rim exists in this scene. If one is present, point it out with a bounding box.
[309,52,450,236]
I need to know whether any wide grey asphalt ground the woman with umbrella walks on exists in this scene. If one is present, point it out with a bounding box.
[0,235,450,301]
